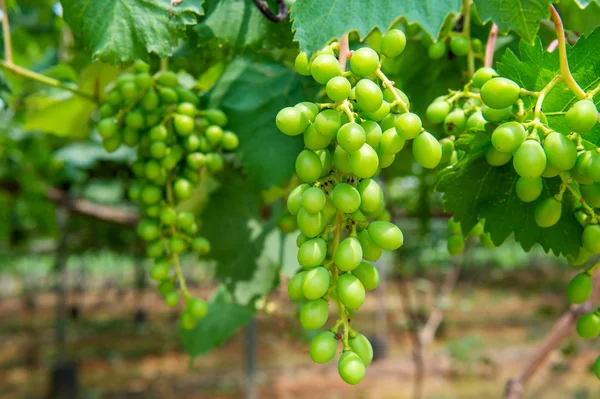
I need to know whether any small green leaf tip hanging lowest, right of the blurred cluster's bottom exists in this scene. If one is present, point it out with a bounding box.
[181,287,254,357]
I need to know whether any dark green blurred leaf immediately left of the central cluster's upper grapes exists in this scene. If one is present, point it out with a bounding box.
[209,57,316,189]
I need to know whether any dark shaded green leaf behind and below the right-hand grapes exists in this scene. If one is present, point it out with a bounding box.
[436,131,583,256]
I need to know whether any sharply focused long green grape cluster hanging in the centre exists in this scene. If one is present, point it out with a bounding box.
[276,29,442,384]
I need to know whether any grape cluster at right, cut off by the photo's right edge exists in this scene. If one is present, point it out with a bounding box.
[427,68,600,264]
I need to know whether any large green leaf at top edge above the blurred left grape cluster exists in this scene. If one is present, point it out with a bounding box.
[61,0,204,64]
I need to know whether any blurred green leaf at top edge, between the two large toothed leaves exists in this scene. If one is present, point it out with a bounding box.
[194,0,292,50]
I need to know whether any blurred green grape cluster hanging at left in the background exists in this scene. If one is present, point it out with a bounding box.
[97,61,238,329]
